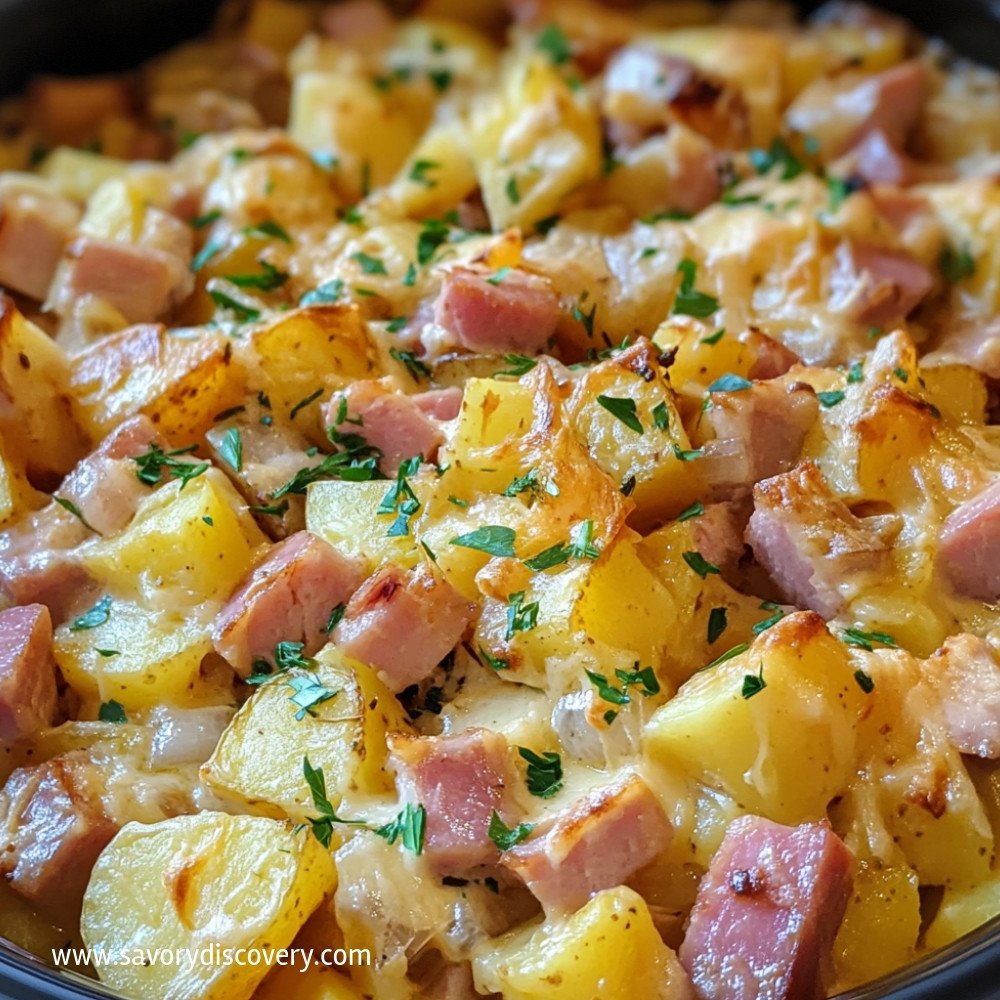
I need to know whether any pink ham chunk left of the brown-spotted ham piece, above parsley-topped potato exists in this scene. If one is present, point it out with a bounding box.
[212,531,365,677]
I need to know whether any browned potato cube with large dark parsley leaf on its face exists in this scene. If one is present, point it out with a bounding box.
[568,342,702,525]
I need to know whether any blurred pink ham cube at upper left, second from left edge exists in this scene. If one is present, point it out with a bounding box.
[48,236,193,323]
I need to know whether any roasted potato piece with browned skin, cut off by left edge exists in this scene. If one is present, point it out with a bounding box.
[0,299,87,479]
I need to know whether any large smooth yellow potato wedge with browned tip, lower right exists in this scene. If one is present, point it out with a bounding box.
[643,612,866,824]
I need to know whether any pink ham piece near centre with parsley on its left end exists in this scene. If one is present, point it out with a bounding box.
[325,379,462,476]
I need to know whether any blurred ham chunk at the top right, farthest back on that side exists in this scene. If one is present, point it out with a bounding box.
[785,60,929,162]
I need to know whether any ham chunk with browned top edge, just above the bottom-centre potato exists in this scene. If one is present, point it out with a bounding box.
[502,774,673,912]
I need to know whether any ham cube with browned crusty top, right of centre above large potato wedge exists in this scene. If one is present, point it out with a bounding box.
[747,462,888,619]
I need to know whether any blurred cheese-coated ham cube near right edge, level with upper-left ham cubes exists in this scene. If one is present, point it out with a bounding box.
[829,242,934,329]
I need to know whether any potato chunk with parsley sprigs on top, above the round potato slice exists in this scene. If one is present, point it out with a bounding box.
[202,646,410,822]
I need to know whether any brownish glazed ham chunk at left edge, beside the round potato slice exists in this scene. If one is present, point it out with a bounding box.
[0,753,118,916]
